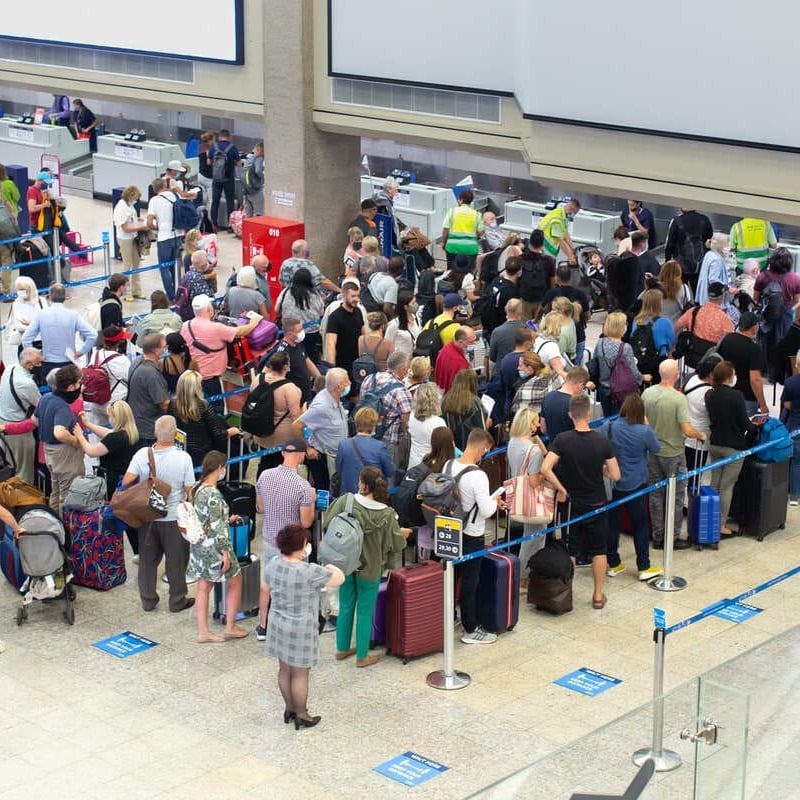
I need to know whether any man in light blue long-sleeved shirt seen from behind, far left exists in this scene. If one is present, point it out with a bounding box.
[22,283,97,377]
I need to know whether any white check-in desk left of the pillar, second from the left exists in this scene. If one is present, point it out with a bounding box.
[92,133,198,197]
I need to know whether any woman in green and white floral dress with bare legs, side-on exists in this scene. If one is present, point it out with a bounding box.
[187,450,247,644]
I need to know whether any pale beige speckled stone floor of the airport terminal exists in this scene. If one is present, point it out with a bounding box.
[0,198,800,800]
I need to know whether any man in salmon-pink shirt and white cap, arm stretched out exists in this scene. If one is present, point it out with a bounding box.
[181,294,262,411]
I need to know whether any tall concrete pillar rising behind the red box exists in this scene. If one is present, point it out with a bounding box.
[263,0,361,278]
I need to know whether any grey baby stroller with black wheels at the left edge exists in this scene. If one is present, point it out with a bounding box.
[17,505,75,625]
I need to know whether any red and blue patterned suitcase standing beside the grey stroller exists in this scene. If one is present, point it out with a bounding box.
[62,506,128,591]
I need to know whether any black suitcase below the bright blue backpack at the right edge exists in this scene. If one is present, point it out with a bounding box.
[729,456,791,542]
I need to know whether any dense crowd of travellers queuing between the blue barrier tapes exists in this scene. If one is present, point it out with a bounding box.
[0,180,800,728]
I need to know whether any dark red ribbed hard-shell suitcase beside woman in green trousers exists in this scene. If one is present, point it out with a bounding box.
[386,561,444,664]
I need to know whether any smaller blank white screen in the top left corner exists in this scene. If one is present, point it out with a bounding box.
[0,0,242,63]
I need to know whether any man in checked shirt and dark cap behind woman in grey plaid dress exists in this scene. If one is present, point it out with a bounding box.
[256,436,317,642]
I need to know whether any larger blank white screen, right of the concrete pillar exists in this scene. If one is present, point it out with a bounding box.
[330,0,800,148]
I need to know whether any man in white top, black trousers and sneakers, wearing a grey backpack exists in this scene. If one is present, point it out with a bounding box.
[444,428,505,644]
